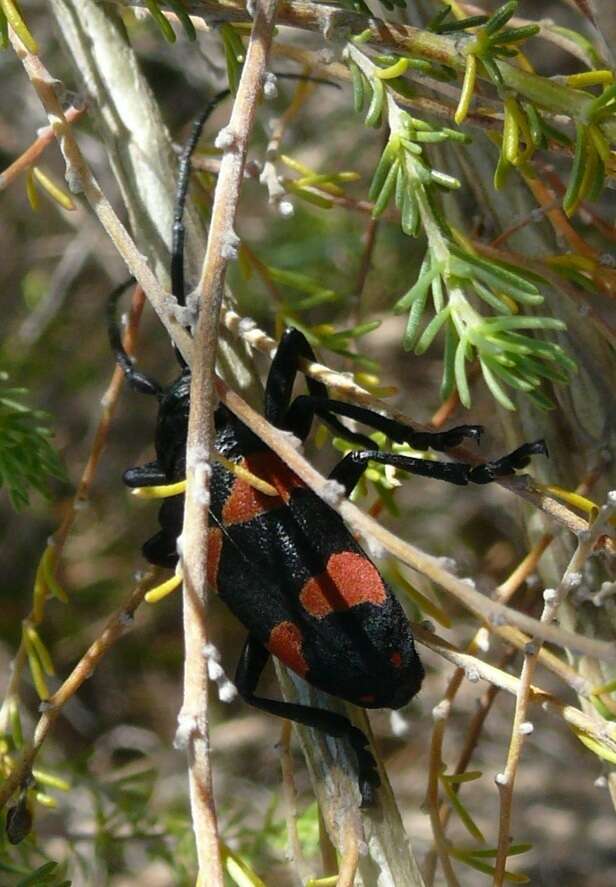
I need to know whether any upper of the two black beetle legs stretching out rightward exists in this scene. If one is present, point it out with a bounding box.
[288,394,483,451]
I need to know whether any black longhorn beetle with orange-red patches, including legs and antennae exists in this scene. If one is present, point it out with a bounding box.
[108,91,547,807]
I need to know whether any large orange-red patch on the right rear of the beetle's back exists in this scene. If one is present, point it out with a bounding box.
[299,551,387,619]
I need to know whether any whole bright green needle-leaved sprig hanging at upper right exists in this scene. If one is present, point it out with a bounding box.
[347,44,576,410]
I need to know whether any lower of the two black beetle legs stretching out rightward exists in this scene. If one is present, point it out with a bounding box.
[330,440,548,496]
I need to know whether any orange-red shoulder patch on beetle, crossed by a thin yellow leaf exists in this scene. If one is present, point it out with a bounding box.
[222,452,304,526]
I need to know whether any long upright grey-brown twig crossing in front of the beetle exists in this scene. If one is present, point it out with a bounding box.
[178,0,277,887]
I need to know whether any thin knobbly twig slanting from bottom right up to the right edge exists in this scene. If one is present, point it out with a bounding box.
[494,493,616,887]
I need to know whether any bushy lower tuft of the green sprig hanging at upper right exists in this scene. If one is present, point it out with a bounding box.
[394,244,576,410]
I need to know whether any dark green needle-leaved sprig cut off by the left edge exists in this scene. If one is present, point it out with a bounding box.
[0,373,66,511]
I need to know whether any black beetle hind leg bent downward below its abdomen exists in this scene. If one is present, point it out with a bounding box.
[235,636,380,807]
